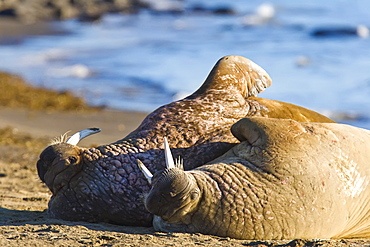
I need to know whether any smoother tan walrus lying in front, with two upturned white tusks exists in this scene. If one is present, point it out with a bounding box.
[138,117,370,240]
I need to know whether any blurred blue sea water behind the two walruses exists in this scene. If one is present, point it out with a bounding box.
[0,0,370,129]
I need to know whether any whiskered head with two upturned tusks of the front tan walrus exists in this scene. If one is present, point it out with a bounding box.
[138,138,201,224]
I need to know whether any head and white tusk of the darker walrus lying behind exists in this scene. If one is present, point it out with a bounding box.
[37,128,100,193]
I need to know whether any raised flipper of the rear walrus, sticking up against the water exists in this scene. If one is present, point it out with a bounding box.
[190,55,272,98]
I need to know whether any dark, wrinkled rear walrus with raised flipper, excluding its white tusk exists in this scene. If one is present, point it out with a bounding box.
[37,56,332,226]
